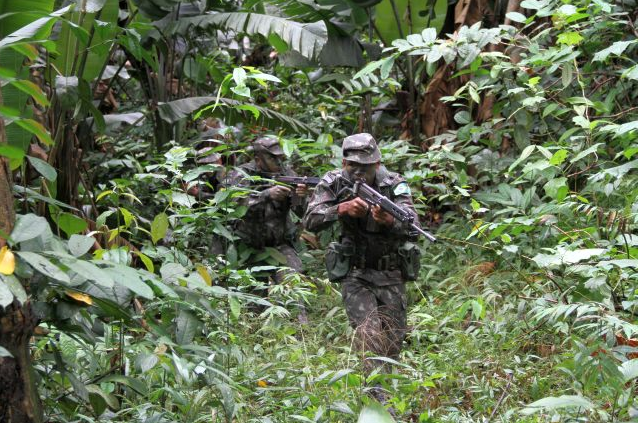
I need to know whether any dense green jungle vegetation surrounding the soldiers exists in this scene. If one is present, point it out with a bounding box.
[0,0,639,423]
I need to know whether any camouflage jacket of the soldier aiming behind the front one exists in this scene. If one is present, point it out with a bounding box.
[224,162,306,248]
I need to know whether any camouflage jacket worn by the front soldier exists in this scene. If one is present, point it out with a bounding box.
[303,166,419,267]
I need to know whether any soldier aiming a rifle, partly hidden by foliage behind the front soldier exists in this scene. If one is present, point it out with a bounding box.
[225,137,308,323]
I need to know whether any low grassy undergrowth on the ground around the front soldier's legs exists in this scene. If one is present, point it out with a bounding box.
[174,250,570,422]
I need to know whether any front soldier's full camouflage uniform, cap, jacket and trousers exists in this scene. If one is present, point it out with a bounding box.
[303,134,418,369]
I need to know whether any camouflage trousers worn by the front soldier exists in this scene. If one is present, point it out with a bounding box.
[341,269,406,373]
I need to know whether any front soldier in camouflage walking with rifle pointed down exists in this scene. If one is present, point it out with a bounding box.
[303,133,418,373]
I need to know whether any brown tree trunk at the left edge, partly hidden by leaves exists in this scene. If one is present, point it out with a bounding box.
[0,87,43,423]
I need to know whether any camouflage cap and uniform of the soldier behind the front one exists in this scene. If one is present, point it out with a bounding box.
[224,138,305,283]
